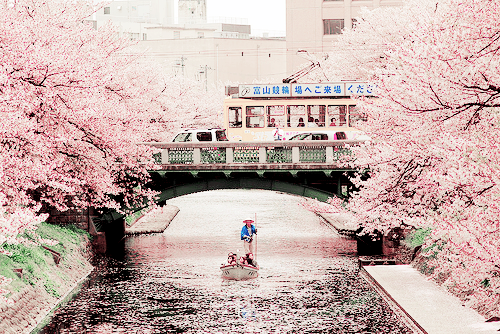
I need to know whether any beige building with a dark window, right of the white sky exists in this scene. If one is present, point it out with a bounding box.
[286,0,403,73]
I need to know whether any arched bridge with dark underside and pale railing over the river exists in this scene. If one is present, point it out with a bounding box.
[56,140,370,253]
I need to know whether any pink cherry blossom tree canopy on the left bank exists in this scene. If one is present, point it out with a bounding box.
[0,0,223,302]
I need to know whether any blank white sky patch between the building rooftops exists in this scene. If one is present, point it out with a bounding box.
[177,0,286,36]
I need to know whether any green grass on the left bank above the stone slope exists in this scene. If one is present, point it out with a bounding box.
[0,223,90,297]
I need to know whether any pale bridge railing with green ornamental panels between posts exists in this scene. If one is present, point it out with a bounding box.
[141,140,363,165]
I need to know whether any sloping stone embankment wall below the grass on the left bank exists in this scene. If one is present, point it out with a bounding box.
[0,237,93,334]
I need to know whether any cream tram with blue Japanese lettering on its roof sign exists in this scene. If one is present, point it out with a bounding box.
[224,82,375,141]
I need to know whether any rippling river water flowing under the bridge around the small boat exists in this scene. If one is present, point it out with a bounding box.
[44,190,410,333]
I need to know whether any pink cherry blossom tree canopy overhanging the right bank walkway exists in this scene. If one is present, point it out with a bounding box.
[312,0,500,316]
